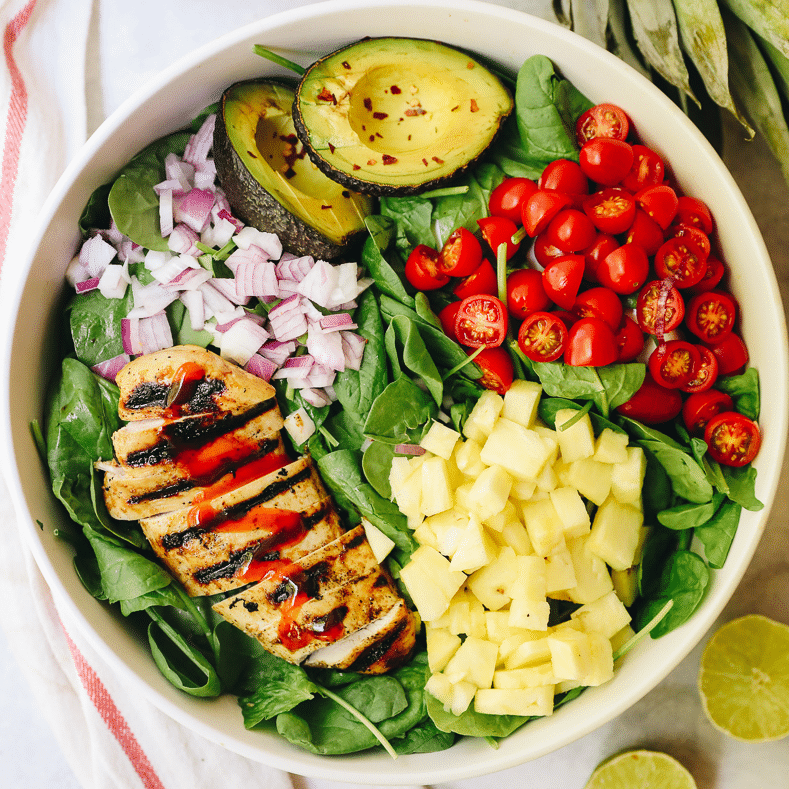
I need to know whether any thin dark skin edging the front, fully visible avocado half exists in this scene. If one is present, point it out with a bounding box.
[291,36,514,197]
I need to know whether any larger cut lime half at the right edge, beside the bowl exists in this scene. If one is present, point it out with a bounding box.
[699,614,789,742]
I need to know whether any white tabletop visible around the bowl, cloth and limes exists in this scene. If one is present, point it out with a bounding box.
[0,0,789,789]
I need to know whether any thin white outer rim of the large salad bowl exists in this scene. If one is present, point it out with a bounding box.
[0,0,789,784]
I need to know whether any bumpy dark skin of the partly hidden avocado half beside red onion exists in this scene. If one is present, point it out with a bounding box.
[213,80,372,260]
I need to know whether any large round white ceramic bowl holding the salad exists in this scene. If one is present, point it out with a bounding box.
[2,0,789,785]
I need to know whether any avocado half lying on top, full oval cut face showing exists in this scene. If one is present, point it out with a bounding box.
[293,38,513,196]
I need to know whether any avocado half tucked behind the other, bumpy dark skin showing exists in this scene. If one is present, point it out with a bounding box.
[214,79,373,259]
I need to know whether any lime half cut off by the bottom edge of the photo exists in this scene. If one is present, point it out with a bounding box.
[584,750,696,789]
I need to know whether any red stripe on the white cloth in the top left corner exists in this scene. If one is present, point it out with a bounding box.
[0,0,36,278]
